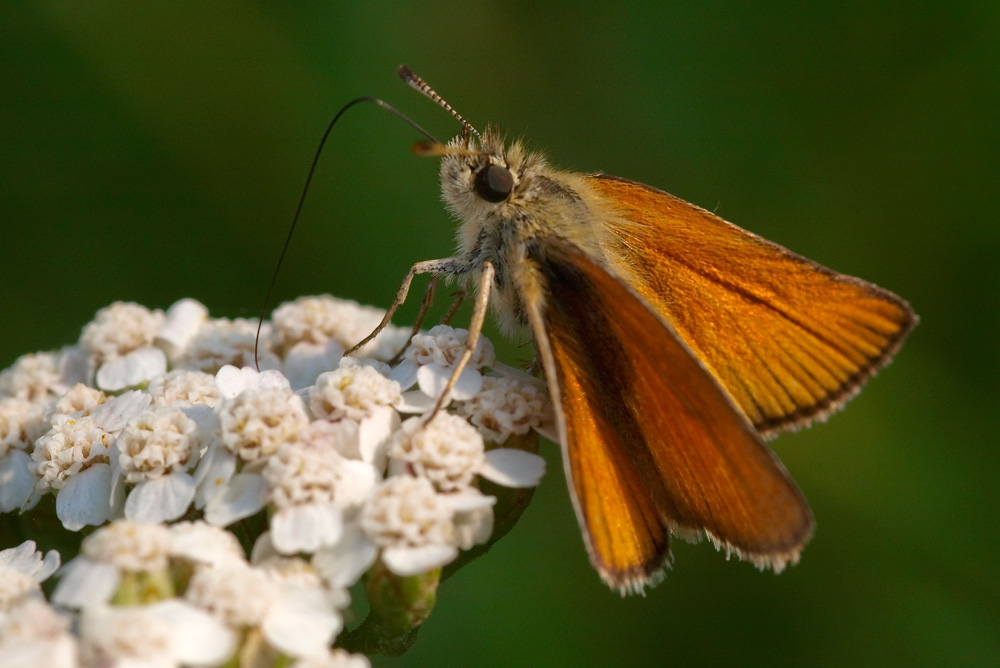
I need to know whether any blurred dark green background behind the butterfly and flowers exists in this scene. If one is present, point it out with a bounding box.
[0,0,1000,667]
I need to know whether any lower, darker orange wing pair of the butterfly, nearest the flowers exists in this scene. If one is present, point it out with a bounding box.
[515,238,813,591]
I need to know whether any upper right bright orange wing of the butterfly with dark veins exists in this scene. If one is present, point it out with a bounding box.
[587,176,917,435]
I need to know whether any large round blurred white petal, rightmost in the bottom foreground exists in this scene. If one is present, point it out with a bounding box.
[261,586,343,657]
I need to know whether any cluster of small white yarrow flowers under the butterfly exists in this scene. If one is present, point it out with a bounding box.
[0,297,552,666]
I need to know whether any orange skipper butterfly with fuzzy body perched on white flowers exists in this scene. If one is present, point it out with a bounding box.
[350,68,917,593]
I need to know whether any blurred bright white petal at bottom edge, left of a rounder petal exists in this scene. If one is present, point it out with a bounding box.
[150,599,236,666]
